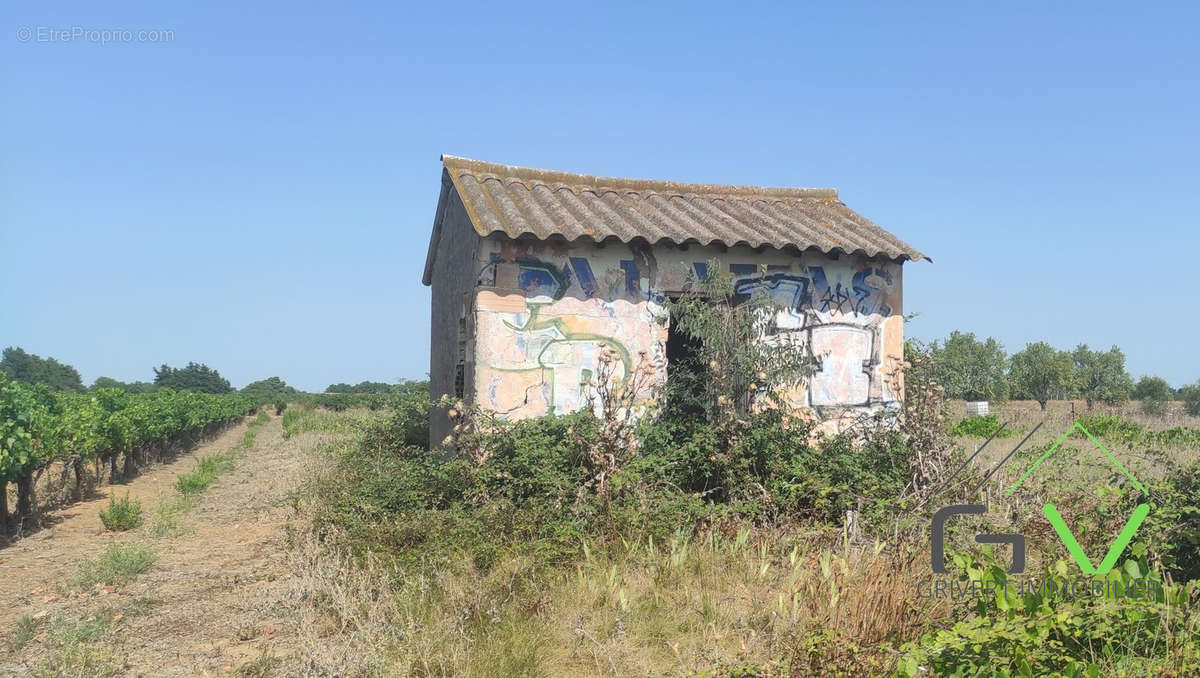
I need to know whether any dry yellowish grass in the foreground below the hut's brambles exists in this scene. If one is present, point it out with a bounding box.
[285,518,948,676]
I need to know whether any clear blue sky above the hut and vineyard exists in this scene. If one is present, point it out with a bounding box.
[0,1,1200,389]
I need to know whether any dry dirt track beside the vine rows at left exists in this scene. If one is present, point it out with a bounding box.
[0,418,308,676]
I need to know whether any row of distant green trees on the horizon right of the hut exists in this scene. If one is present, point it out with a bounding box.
[928,331,1200,416]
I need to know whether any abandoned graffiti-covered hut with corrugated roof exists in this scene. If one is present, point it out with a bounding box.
[422,155,925,444]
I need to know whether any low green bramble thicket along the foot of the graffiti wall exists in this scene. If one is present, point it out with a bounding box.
[316,396,910,566]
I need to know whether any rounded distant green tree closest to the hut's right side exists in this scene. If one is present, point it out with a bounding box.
[929,330,1009,402]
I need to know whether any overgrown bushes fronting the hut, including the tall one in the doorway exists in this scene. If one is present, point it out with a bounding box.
[312,265,949,563]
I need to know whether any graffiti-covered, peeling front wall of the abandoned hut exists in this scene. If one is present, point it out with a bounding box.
[473,235,904,432]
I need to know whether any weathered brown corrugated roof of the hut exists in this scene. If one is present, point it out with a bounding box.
[426,155,932,284]
